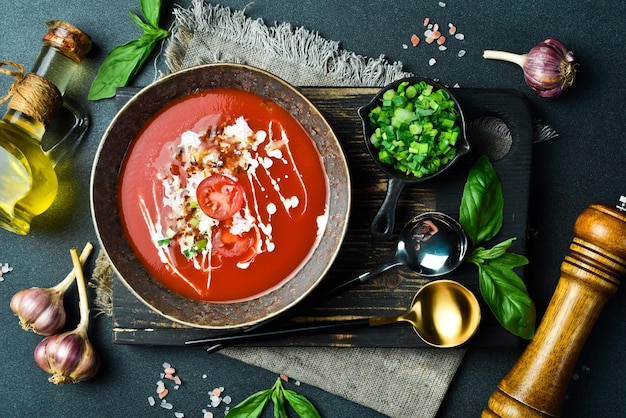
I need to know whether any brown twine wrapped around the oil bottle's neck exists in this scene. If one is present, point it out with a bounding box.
[0,61,63,126]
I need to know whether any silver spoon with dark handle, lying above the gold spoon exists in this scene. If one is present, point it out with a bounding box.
[185,212,468,352]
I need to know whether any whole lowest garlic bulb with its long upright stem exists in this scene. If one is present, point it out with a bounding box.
[35,248,100,385]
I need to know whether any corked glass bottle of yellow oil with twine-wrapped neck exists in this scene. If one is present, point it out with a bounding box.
[0,20,92,235]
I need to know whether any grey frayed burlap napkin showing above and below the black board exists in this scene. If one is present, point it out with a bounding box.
[158,0,465,417]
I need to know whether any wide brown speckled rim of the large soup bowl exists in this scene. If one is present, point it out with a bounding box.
[90,63,352,329]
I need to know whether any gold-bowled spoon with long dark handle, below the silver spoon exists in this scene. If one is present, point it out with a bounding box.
[186,280,480,348]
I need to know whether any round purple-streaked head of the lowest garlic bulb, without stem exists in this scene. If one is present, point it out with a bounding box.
[34,330,100,385]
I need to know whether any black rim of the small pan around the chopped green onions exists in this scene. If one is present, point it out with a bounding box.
[357,76,470,183]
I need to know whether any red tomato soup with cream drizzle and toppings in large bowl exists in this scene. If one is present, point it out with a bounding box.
[118,88,329,302]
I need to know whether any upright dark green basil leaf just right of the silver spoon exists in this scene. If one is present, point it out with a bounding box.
[459,155,504,245]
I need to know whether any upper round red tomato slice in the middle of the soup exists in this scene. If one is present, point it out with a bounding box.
[196,174,244,221]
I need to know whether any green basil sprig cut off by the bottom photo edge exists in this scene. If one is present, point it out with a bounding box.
[228,377,320,418]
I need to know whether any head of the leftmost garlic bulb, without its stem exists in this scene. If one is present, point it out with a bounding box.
[11,287,66,335]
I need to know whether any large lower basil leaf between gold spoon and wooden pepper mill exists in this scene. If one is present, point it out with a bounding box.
[478,260,536,339]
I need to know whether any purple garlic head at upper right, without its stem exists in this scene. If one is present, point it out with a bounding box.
[523,38,577,98]
